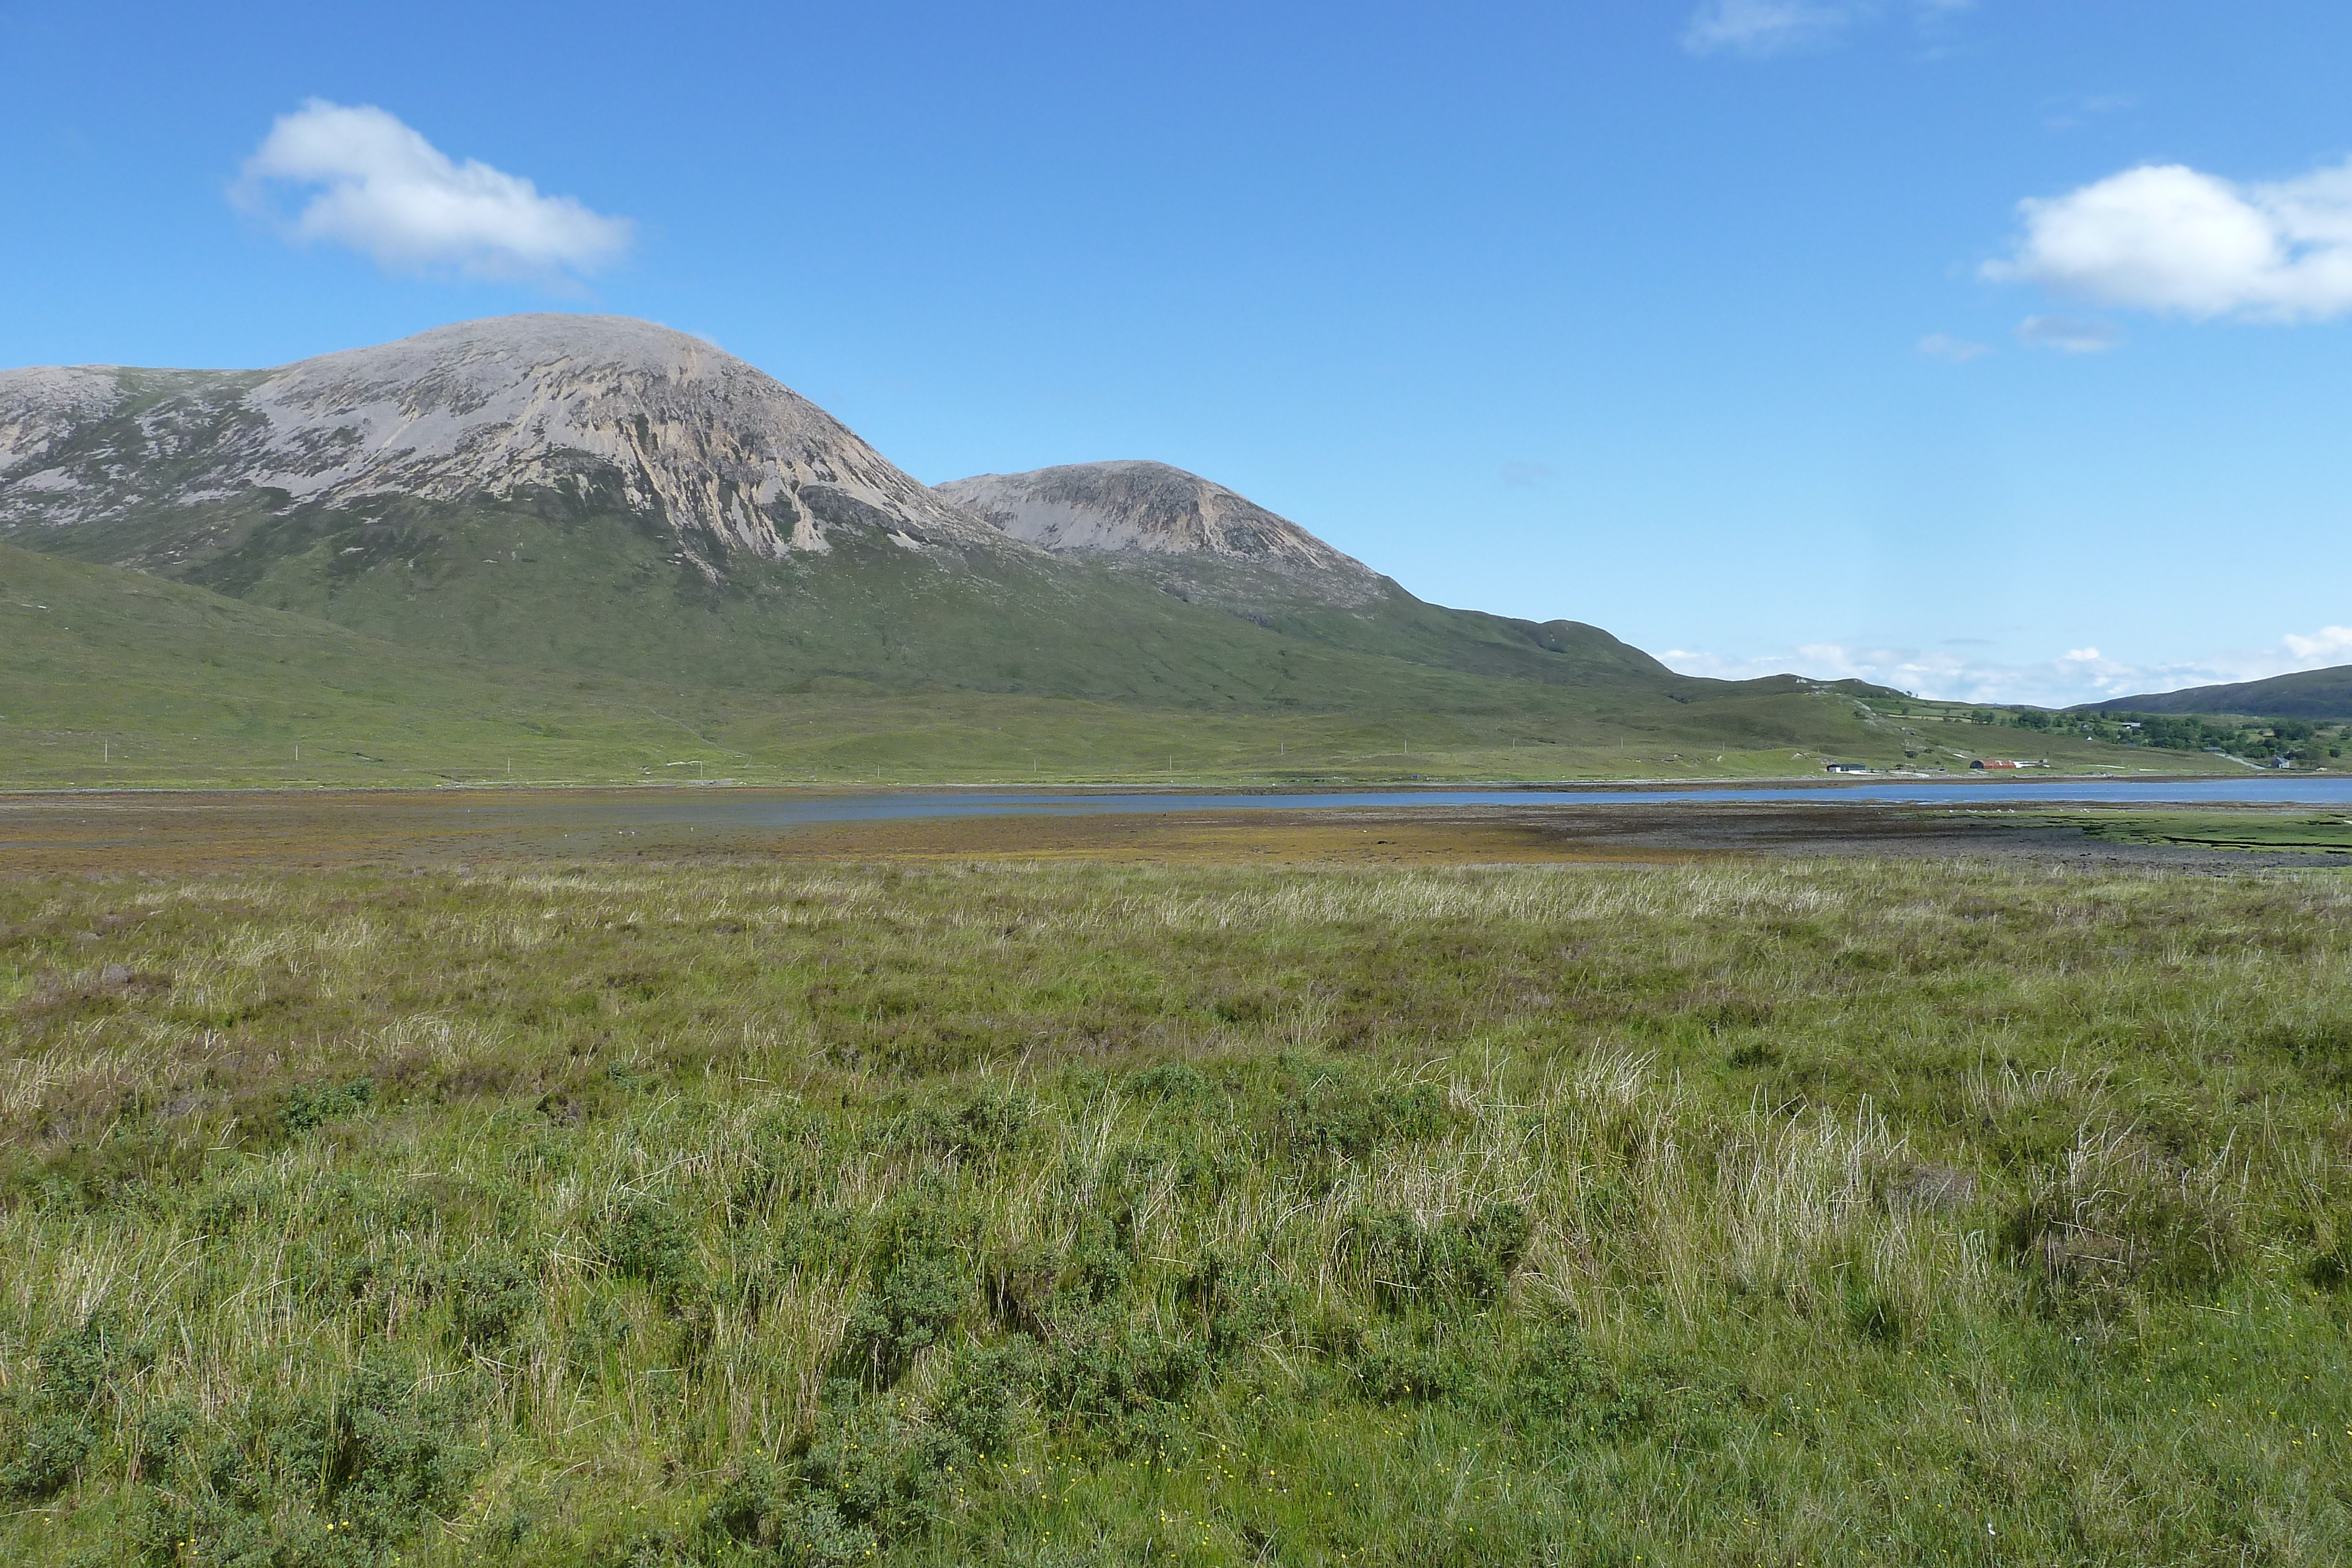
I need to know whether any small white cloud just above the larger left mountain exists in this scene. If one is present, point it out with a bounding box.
[230,99,633,280]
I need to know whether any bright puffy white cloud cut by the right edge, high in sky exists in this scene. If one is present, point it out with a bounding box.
[1983,160,2352,322]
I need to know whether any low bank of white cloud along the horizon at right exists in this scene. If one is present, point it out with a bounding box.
[1658,626,2352,708]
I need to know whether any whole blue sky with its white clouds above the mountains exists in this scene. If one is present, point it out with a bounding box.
[0,0,2352,703]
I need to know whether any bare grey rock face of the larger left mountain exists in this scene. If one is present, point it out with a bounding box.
[0,315,1004,569]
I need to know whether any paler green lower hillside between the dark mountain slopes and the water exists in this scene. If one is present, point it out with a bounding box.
[0,546,2098,787]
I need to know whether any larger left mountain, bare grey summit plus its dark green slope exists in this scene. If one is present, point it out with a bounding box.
[0,315,1364,701]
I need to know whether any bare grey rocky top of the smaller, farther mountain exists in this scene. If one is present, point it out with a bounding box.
[938,461,1383,602]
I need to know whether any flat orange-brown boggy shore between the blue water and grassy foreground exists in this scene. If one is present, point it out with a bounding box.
[0,790,2352,874]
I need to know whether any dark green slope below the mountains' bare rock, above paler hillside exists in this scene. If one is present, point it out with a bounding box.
[19,470,1731,713]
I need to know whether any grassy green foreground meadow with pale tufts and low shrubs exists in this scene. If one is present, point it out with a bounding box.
[0,862,2352,1568]
